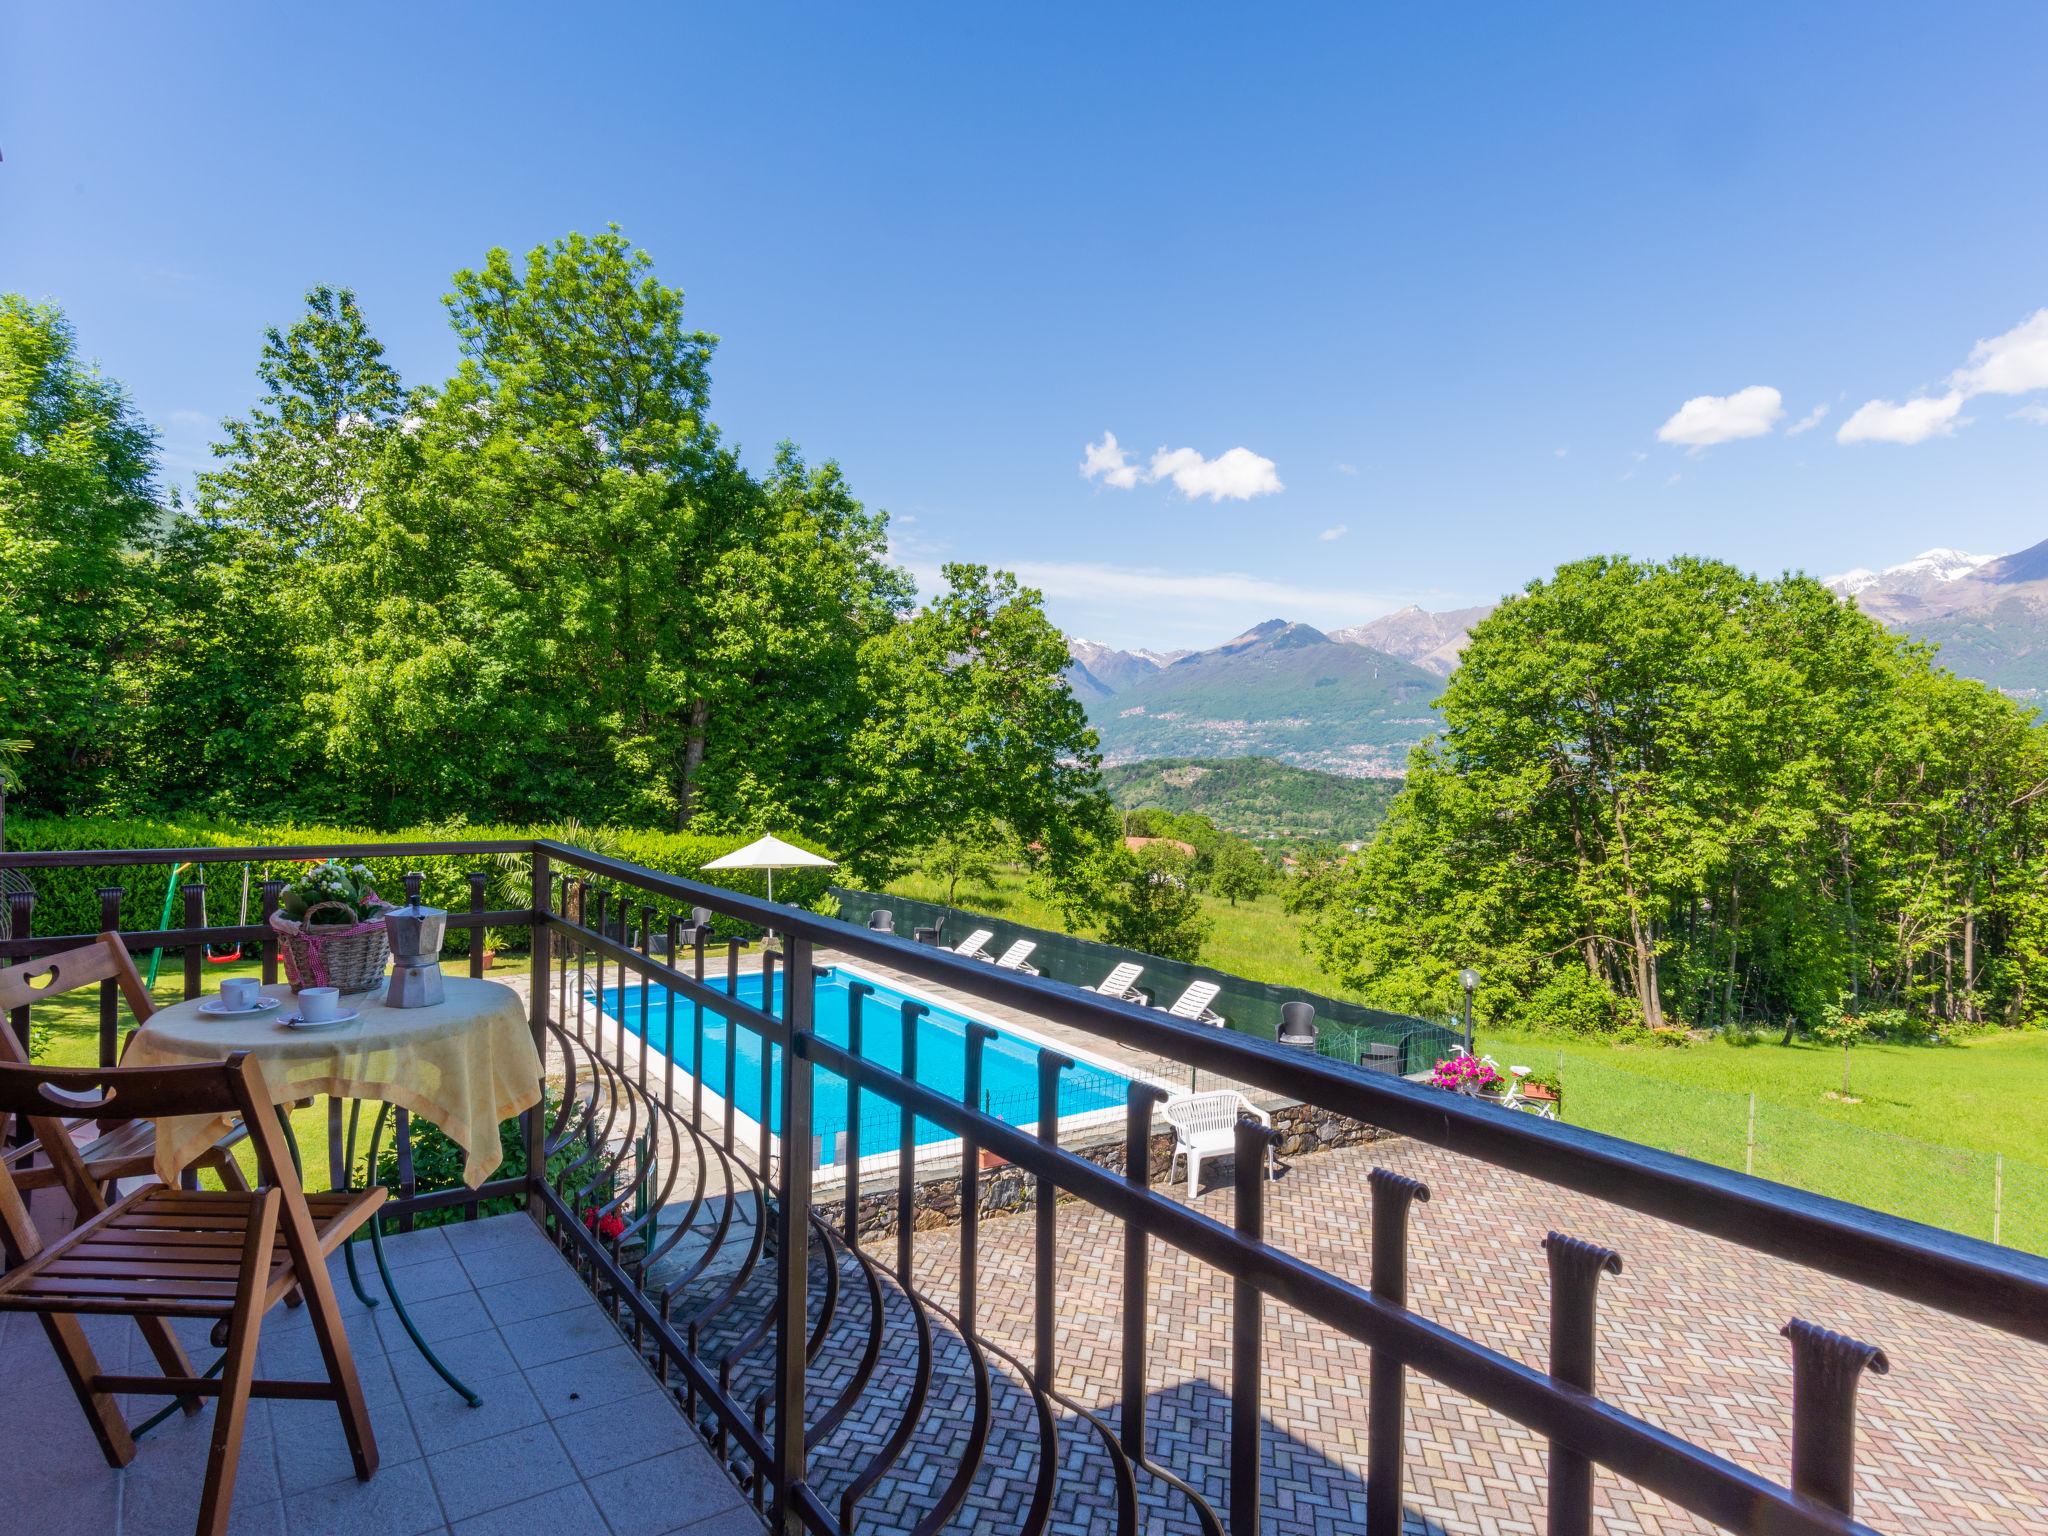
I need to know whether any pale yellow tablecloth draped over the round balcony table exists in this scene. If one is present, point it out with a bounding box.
[121,977,541,1188]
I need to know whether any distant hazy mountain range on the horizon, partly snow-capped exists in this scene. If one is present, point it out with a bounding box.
[1067,541,2048,778]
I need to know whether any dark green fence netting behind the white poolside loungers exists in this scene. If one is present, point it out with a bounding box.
[831,885,1462,1073]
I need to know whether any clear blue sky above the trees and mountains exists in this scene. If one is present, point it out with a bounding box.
[0,4,2048,647]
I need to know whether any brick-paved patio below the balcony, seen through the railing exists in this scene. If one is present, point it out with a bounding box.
[774,1141,2048,1536]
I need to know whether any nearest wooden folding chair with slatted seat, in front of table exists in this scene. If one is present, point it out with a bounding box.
[0,1053,385,1536]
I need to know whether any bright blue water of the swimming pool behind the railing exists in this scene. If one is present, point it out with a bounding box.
[604,971,1130,1165]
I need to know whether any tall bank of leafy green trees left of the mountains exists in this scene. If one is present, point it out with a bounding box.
[0,229,1112,879]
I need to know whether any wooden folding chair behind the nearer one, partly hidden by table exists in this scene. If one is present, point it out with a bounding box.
[0,934,248,1219]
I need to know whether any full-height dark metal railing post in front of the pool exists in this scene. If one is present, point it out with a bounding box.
[762,936,817,1536]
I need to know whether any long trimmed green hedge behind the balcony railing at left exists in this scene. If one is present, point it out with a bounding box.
[6,817,831,954]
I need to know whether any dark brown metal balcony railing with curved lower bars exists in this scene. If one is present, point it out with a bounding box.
[0,842,2048,1536]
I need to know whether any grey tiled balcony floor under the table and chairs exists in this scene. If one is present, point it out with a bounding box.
[0,1214,762,1536]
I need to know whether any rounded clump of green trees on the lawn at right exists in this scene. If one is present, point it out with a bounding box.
[1311,557,2048,1034]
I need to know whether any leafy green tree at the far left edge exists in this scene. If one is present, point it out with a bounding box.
[0,293,162,815]
